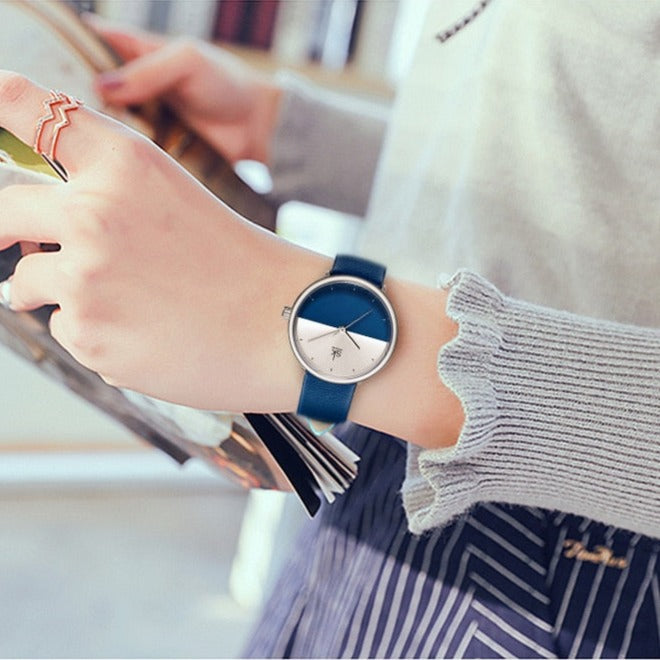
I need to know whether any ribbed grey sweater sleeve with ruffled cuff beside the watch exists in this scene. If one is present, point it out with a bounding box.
[403,272,660,537]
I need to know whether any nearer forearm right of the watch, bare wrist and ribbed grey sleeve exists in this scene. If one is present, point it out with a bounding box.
[268,253,660,536]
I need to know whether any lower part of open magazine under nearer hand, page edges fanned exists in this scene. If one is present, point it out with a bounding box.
[0,98,359,516]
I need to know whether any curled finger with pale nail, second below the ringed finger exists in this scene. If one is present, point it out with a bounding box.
[10,252,59,312]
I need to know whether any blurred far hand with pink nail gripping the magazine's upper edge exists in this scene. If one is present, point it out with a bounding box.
[87,15,281,163]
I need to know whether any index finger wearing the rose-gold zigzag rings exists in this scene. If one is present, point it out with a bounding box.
[0,69,116,174]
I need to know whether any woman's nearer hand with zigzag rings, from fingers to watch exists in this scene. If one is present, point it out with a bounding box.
[0,72,327,411]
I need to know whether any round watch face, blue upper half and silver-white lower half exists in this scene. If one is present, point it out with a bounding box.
[289,275,397,383]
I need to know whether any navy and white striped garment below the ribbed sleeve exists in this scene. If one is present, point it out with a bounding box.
[246,426,660,658]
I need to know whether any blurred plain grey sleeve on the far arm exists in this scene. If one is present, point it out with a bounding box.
[269,76,388,216]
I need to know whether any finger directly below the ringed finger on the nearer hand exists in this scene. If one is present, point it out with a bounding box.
[0,185,62,250]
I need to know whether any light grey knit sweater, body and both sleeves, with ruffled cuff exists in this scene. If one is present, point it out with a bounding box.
[272,0,660,536]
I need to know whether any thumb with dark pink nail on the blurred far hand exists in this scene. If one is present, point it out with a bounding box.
[96,42,194,105]
